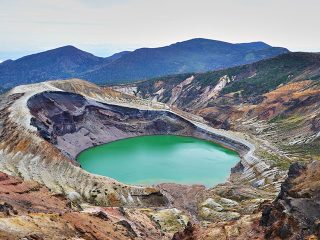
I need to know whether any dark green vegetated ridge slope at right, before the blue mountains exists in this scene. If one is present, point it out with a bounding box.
[131,52,320,104]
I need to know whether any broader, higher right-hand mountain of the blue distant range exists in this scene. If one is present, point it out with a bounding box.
[80,38,288,83]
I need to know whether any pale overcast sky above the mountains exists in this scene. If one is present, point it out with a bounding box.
[0,0,320,61]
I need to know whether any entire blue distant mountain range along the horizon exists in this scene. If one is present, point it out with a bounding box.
[0,39,288,89]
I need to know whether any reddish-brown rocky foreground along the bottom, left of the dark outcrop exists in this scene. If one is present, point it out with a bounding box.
[0,170,270,240]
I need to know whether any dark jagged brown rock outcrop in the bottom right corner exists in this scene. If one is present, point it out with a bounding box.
[260,162,320,239]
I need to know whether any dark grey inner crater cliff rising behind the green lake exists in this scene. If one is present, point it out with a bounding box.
[27,92,250,160]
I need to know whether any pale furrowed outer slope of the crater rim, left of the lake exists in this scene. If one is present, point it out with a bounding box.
[0,89,167,207]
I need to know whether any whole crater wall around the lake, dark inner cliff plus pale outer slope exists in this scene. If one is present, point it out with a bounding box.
[0,83,249,210]
